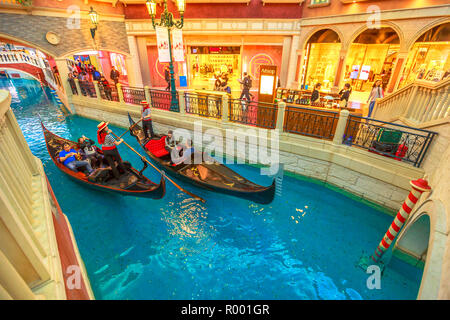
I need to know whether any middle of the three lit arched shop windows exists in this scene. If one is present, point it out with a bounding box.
[344,27,400,95]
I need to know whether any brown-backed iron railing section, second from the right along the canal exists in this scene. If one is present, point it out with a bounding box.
[283,106,339,140]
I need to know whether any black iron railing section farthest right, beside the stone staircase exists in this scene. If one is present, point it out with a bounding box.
[342,115,437,167]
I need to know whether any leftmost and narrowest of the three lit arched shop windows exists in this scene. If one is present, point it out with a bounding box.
[300,29,341,92]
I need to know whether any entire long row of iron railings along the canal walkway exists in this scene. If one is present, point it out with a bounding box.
[68,79,437,167]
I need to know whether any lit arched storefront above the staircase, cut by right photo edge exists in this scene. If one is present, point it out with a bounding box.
[399,23,450,88]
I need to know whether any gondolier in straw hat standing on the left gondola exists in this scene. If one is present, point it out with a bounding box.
[97,121,127,179]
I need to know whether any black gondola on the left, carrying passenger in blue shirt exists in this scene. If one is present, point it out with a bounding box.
[41,122,166,199]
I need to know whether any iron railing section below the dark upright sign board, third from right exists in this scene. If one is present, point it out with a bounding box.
[228,99,278,129]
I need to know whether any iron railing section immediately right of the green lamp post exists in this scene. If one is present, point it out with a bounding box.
[184,92,222,119]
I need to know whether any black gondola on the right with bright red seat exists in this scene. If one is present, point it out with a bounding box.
[128,114,275,204]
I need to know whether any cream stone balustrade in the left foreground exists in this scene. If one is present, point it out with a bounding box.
[0,90,92,300]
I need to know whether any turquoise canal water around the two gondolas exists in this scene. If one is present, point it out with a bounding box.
[0,80,421,299]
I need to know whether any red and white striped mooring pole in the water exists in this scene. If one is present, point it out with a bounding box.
[372,179,431,262]
